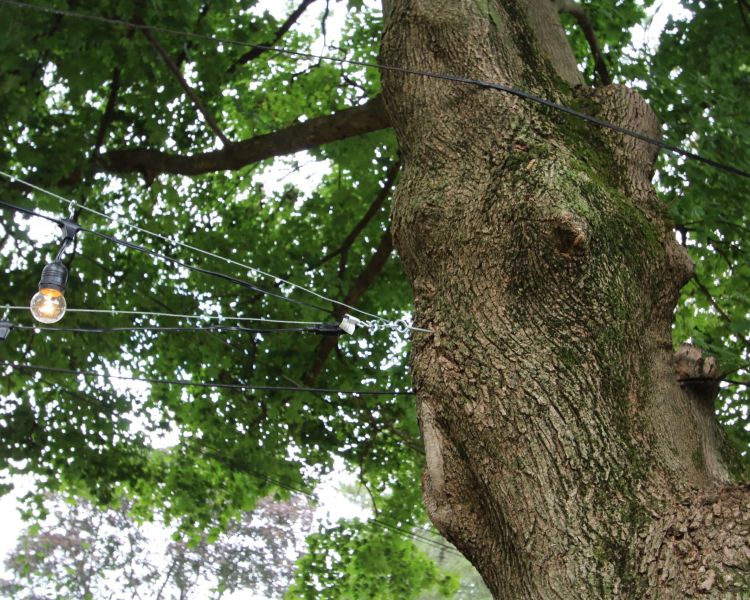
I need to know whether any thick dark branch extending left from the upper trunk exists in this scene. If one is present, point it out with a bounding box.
[98,96,390,179]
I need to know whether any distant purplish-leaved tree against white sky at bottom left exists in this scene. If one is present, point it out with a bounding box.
[2,495,312,599]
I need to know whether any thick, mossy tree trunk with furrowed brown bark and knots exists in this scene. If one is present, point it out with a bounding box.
[382,0,750,599]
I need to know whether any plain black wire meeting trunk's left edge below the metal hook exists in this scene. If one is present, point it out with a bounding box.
[0,361,414,396]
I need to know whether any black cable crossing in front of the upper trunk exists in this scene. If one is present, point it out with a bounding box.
[0,0,750,179]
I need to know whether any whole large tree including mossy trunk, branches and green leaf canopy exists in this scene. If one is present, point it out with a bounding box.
[0,0,750,598]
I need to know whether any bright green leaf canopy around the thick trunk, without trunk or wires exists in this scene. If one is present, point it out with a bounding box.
[0,0,750,598]
